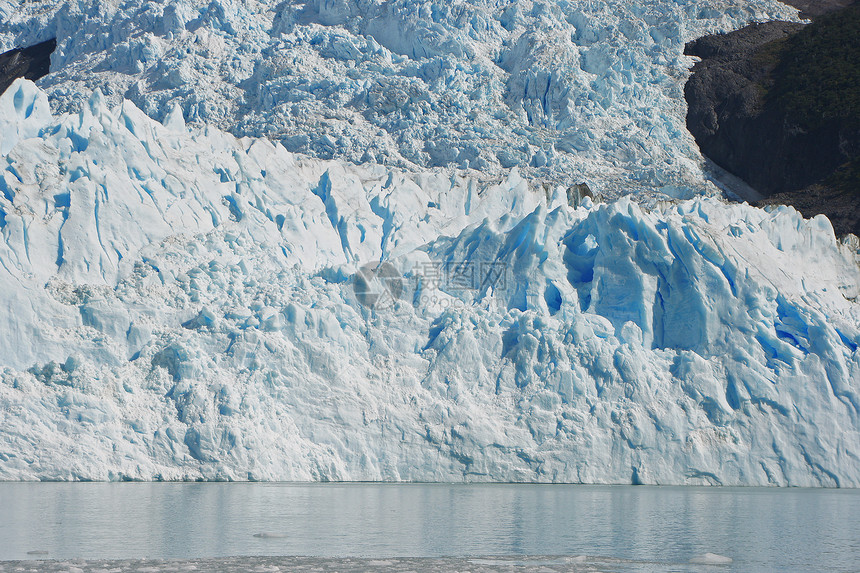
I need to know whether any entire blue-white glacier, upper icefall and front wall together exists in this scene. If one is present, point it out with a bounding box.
[0,0,860,487]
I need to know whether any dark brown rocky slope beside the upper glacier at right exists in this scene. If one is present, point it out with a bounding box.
[684,3,860,234]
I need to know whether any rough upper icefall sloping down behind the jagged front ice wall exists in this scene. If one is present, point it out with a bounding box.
[0,0,796,197]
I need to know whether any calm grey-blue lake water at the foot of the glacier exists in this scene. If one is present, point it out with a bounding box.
[0,483,860,572]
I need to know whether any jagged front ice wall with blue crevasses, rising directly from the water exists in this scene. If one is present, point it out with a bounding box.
[0,85,860,486]
